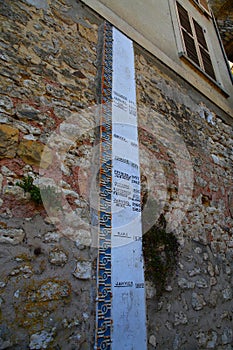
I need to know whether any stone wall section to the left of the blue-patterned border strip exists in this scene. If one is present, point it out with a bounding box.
[0,0,97,349]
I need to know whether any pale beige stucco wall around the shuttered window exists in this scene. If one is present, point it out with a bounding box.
[83,0,233,116]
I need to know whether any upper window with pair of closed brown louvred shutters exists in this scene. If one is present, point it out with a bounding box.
[177,0,216,80]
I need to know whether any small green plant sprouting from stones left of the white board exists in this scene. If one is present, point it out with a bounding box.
[17,176,62,210]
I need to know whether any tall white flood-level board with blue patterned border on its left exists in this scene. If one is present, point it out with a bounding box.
[95,23,147,350]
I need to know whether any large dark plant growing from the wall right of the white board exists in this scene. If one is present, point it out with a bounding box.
[142,205,179,298]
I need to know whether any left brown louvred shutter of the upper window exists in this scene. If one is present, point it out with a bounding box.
[177,2,200,66]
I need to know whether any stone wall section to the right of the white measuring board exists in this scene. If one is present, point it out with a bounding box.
[136,48,233,350]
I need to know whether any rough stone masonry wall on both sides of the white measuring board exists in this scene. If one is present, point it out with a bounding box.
[0,0,233,350]
